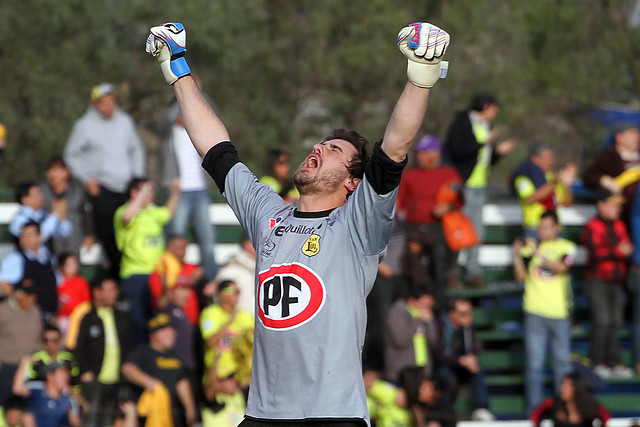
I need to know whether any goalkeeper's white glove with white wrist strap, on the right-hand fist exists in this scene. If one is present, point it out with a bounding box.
[398,22,449,87]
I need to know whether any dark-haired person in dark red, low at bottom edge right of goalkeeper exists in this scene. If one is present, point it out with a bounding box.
[530,374,611,427]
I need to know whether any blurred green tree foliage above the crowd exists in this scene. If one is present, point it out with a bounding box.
[0,0,640,191]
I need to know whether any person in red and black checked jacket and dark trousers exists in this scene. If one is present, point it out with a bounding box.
[581,190,633,378]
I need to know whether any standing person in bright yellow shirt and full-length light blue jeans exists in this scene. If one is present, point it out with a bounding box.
[513,211,577,412]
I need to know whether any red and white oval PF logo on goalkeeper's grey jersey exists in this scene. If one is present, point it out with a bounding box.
[256,263,326,330]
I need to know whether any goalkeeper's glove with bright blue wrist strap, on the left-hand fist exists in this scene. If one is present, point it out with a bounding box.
[147,22,191,85]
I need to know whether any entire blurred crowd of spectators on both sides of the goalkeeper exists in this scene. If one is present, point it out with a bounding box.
[0,83,640,427]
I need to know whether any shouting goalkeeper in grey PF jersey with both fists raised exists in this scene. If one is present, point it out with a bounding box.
[147,23,449,427]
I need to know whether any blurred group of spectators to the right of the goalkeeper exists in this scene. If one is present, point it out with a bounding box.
[364,93,640,425]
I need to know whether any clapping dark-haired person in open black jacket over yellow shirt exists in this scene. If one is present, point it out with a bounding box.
[443,92,516,287]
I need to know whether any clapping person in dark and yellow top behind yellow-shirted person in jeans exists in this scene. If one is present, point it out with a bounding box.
[512,142,578,238]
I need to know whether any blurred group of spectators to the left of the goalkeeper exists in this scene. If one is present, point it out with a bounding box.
[0,83,255,426]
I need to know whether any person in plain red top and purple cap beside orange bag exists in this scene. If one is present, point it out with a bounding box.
[396,135,462,309]
